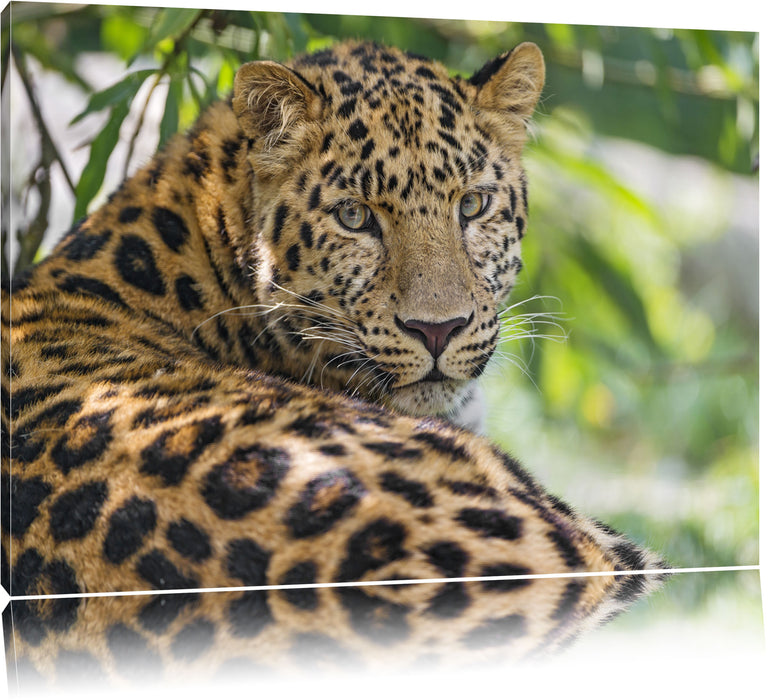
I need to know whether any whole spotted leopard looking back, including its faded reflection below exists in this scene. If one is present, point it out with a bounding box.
[0,40,668,683]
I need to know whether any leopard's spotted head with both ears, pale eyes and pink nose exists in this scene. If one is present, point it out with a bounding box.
[234,44,544,422]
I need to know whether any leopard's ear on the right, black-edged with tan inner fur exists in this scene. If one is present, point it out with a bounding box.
[469,42,544,125]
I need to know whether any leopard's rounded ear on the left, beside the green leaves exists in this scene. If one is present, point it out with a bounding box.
[232,61,323,150]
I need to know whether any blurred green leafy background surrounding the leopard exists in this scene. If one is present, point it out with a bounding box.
[2,3,761,648]
